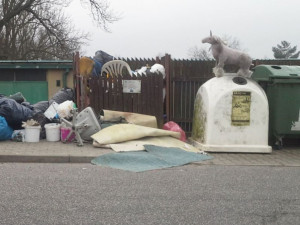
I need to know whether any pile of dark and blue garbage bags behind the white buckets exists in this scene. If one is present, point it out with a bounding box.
[0,88,74,140]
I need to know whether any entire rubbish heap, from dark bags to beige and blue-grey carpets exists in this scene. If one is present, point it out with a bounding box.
[0,89,211,172]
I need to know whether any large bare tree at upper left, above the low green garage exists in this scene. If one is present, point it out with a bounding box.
[0,0,118,59]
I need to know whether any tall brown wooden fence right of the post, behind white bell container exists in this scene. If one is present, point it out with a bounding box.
[166,57,300,136]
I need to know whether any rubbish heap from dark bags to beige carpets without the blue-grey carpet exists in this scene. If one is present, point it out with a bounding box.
[0,89,190,151]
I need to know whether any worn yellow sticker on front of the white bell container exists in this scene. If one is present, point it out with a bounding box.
[231,91,251,126]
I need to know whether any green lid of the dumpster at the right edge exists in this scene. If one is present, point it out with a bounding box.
[251,65,300,81]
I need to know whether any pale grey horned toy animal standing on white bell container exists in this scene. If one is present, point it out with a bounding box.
[202,31,252,77]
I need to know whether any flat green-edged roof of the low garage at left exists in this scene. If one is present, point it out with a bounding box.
[0,60,73,69]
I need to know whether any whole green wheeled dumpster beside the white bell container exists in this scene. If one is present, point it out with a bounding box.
[252,65,300,149]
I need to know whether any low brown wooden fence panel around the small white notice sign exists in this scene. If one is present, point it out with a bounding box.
[89,74,163,127]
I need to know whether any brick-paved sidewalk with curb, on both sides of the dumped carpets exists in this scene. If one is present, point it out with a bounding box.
[0,140,300,166]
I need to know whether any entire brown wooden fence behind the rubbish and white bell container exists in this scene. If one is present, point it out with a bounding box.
[75,51,300,135]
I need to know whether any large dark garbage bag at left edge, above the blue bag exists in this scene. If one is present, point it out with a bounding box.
[0,97,33,130]
